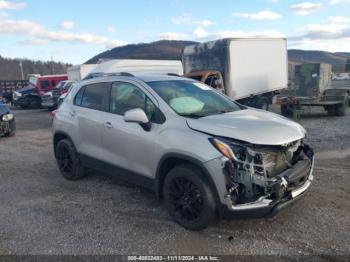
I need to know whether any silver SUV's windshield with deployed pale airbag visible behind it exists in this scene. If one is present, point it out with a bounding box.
[147,80,240,118]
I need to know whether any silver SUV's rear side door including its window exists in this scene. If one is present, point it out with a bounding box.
[70,83,110,160]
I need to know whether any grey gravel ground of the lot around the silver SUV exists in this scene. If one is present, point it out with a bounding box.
[0,103,350,256]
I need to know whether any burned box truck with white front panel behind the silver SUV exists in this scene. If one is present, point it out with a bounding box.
[182,38,288,110]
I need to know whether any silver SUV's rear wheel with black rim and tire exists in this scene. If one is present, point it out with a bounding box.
[55,139,85,180]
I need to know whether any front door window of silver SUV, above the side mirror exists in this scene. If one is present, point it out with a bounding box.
[110,82,156,121]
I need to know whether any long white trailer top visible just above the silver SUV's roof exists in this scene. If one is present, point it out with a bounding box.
[90,59,183,75]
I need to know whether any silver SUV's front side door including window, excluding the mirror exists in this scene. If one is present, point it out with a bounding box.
[102,81,161,177]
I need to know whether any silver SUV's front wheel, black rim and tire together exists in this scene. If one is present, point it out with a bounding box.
[163,165,215,230]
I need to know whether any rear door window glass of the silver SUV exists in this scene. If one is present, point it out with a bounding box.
[74,83,110,110]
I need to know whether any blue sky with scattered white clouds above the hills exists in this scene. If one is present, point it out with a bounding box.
[0,0,350,64]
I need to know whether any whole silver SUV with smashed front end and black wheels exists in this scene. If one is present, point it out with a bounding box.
[53,73,314,230]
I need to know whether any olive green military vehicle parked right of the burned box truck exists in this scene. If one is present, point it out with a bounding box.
[277,63,350,119]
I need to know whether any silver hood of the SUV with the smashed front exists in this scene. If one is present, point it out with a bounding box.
[187,109,306,145]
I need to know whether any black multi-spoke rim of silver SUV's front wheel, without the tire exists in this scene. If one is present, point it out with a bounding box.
[168,177,203,221]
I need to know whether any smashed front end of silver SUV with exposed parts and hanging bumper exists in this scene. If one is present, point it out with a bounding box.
[202,141,315,217]
